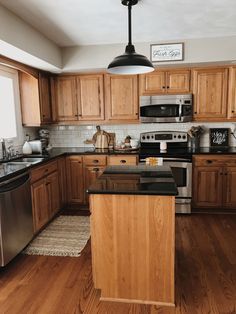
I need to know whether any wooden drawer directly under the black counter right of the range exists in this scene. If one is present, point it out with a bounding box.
[193,155,236,167]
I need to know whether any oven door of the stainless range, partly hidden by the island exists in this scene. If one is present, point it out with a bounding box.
[163,158,192,199]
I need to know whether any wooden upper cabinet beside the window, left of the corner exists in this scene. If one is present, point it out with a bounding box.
[19,72,53,126]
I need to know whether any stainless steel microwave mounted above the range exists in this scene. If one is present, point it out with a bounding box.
[140,94,193,123]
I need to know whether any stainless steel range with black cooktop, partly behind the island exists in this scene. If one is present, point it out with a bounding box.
[139,131,192,213]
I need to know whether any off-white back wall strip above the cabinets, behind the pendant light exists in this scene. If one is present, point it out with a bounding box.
[62,36,236,72]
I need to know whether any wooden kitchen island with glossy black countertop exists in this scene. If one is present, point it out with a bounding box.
[88,166,177,306]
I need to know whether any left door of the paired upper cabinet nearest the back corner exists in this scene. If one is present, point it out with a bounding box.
[55,76,78,121]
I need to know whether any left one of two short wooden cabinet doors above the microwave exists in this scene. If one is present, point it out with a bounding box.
[139,70,166,95]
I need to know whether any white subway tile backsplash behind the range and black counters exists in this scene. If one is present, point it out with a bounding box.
[47,122,236,147]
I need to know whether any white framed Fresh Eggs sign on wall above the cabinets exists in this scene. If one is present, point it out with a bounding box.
[150,43,184,62]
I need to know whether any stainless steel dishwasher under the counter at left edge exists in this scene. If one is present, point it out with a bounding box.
[0,173,33,266]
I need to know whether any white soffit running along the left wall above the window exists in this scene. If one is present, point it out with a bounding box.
[0,5,62,71]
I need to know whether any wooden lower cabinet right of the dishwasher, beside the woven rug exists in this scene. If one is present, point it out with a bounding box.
[31,161,60,232]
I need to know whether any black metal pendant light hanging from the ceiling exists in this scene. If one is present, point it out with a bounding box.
[107,0,154,75]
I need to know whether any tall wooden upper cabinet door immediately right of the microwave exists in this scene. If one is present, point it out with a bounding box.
[193,68,228,121]
